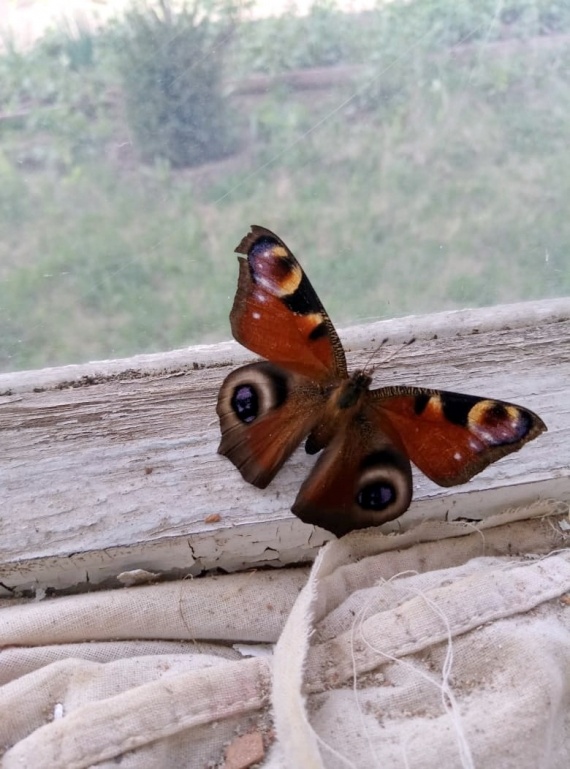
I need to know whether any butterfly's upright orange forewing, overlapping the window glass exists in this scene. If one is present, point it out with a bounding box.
[230,225,347,381]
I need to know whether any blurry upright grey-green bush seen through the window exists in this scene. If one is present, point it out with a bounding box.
[117,0,239,168]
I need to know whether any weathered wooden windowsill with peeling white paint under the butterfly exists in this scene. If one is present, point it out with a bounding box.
[0,299,570,592]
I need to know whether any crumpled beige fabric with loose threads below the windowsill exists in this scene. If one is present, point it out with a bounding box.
[0,505,570,769]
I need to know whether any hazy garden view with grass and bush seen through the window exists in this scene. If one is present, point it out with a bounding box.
[0,0,570,371]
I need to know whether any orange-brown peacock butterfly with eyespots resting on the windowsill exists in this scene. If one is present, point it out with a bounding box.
[217,225,546,537]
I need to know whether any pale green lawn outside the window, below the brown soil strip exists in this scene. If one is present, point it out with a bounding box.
[0,0,570,370]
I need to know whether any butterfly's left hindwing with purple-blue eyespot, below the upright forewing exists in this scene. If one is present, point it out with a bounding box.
[217,363,324,488]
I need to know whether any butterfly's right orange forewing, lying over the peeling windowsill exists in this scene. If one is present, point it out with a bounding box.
[366,387,546,486]
